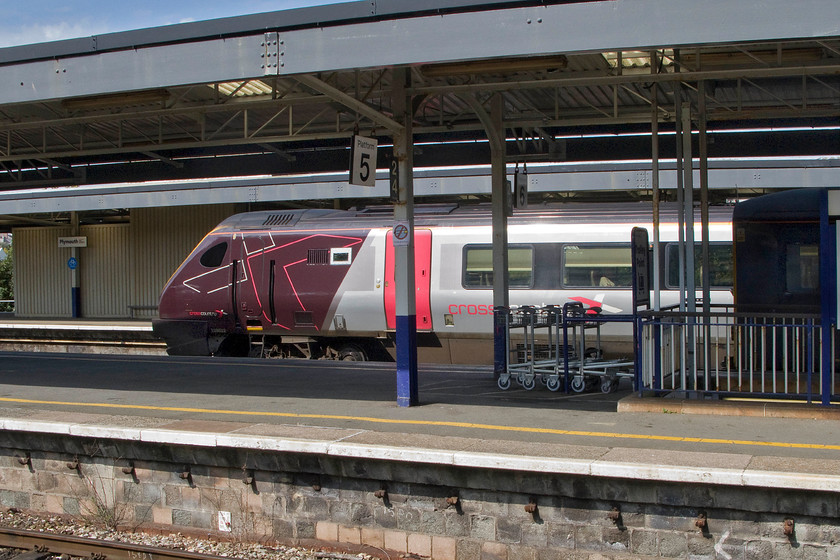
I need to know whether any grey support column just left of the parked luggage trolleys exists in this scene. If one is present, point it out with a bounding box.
[487,93,510,377]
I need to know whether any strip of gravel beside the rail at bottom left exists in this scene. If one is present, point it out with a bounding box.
[0,508,380,560]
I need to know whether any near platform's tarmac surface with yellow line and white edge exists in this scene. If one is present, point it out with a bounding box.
[0,352,840,492]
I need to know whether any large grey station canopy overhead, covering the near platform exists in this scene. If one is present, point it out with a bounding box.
[0,0,840,225]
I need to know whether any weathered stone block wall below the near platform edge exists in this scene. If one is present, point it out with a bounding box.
[0,432,840,560]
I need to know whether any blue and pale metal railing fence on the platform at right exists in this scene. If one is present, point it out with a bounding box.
[636,307,840,404]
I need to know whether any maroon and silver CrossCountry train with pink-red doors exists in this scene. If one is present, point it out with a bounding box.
[153,202,733,364]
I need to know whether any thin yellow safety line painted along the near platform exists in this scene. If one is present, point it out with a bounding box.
[0,397,840,451]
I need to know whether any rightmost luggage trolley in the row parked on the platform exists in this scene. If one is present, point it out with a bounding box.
[563,301,634,393]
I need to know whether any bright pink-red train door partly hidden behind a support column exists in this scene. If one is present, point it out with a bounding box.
[384,229,432,331]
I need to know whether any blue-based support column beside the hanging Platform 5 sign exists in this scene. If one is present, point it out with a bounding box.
[392,69,420,406]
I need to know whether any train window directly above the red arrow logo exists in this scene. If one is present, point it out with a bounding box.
[563,245,633,288]
